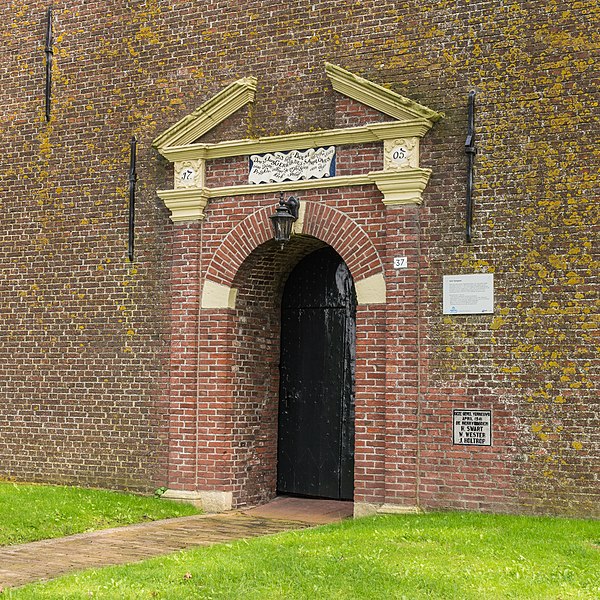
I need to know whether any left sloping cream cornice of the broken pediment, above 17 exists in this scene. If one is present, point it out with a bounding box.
[152,77,256,153]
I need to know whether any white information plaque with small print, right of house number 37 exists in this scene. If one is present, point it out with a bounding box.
[444,273,494,315]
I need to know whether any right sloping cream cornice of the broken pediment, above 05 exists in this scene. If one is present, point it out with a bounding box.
[325,63,443,127]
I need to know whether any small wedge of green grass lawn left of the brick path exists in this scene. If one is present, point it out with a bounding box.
[0,482,198,546]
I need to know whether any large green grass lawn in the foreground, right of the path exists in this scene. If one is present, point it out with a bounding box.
[5,513,600,600]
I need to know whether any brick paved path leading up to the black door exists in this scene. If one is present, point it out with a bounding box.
[0,499,351,589]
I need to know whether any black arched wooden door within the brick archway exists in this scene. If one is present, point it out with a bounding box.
[277,248,356,500]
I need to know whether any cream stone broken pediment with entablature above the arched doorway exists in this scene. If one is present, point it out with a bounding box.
[153,63,442,221]
